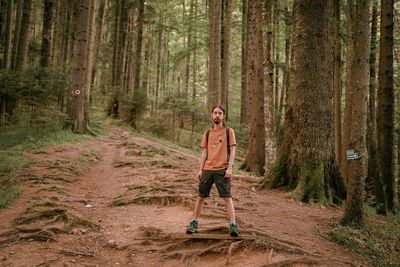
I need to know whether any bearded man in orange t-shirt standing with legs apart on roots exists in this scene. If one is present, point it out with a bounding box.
[186,106,239,237]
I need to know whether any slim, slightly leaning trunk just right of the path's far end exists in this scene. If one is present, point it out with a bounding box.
[131,0,145,128]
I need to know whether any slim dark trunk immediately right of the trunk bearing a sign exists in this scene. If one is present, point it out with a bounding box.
[366,0,387,215]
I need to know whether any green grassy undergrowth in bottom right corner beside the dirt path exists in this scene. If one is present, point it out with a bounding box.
[328,219,400,266]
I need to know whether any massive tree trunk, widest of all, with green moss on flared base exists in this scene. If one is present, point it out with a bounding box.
[264,0,344,204]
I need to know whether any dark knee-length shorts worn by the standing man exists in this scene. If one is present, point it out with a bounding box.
[199,170,232,197]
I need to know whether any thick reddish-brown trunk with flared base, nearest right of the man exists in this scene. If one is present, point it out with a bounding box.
[242,0,265,175]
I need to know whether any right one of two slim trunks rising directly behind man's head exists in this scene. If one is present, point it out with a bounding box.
[221,0,233,120]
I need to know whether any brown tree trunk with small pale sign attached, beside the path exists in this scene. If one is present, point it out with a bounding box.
[342,0,370,226]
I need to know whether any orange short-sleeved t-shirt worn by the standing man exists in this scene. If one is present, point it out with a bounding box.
[201,127,236,170]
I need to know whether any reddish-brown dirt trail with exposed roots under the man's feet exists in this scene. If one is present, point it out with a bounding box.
[0,126,366,267]
